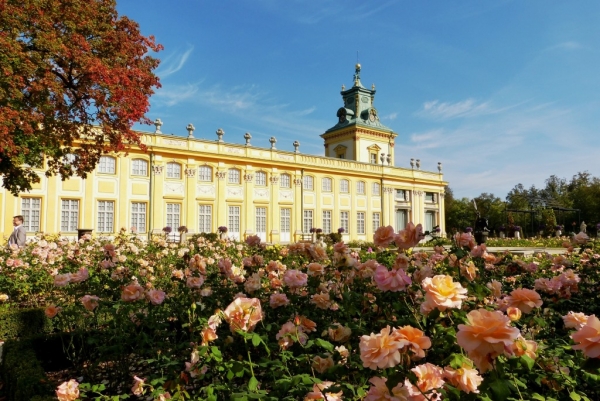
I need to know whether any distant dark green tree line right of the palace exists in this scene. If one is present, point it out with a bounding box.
[444,171,600,236]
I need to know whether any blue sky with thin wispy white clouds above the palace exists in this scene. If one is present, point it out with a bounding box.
[117,0,600,199]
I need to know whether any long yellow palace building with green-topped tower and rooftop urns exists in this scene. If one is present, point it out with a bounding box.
[0,64,447,243]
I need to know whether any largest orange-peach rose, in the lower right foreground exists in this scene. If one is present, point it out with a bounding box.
[456,309,521,372]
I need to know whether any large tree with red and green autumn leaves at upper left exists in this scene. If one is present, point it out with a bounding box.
[0,0,162,195]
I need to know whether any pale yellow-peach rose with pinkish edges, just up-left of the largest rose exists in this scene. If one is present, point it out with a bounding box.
[421,275,467,313]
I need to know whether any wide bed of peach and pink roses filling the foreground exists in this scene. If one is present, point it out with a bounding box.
[0,224,600,401]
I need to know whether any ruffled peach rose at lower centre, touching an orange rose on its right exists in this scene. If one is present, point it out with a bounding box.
[360,326,408,370]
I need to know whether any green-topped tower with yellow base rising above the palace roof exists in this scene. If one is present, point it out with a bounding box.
[321,64,398,166]
